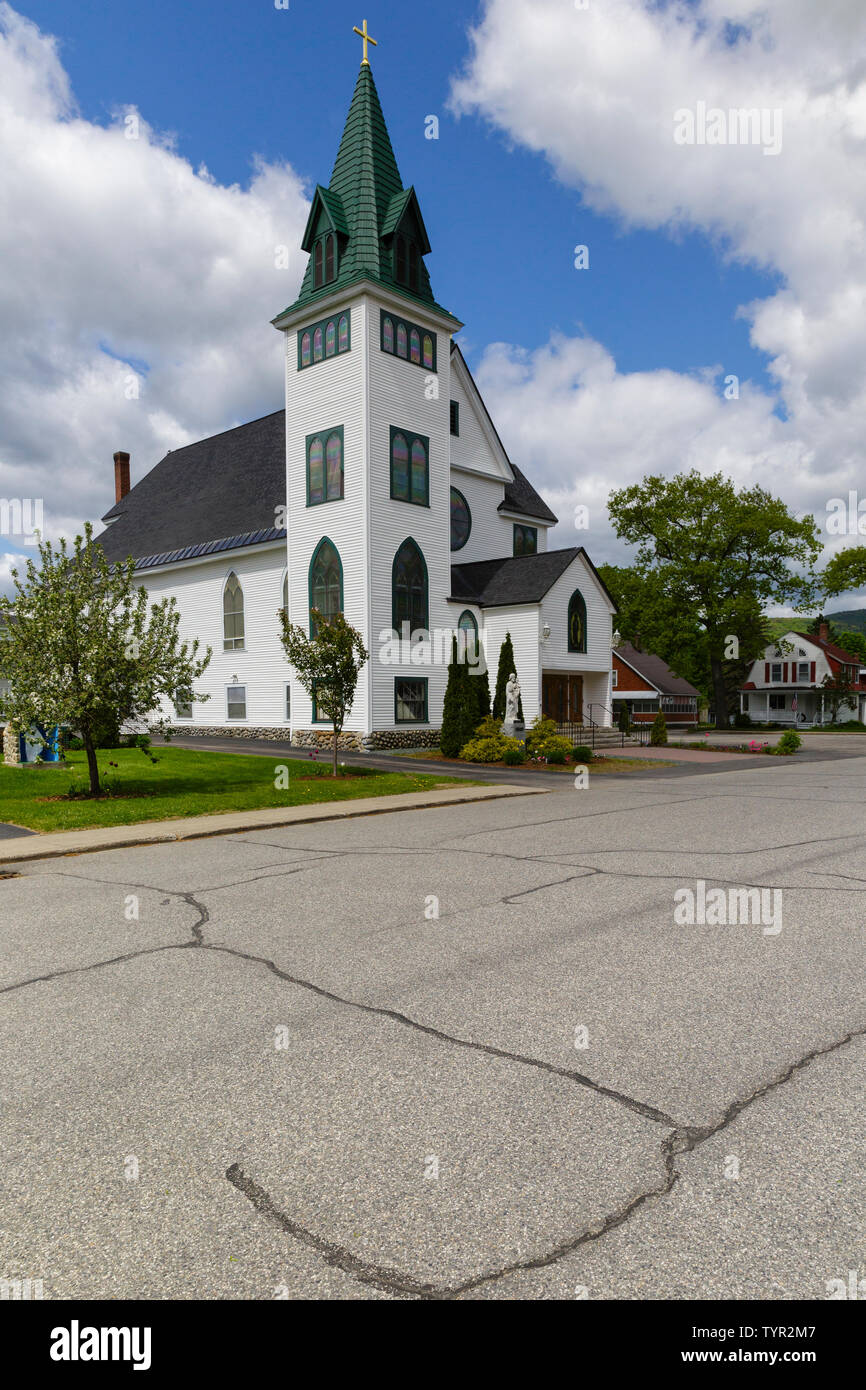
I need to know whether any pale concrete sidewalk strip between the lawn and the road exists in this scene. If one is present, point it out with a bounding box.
[0,783,546,869]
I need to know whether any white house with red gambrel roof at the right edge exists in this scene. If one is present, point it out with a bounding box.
[740,623,866,726]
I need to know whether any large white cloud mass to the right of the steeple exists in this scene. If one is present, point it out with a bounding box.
[453,0,866,597]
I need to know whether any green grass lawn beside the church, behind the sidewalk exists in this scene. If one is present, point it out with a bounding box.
[0,748,471,830]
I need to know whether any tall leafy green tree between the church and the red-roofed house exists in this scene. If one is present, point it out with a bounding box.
[609,470,822,728]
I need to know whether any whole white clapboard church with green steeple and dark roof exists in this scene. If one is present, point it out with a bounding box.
[99,43,616,748]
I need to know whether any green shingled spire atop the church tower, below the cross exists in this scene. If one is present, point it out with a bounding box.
[274,63,453,322]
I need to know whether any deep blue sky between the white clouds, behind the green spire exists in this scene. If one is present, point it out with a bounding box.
[19,0,776,381]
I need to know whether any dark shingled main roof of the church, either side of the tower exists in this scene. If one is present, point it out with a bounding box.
[99,410,553,566]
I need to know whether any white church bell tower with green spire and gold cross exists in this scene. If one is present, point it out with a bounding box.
[274,21,463,744]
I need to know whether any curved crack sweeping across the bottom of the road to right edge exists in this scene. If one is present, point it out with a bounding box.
[225,1024,866,1301]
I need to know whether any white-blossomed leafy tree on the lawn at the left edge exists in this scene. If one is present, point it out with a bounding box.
[0,523,211,796]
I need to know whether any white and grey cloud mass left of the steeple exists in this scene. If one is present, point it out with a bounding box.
[0,4,309,549]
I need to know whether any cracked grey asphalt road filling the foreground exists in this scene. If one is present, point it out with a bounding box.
[0,759,866,1300]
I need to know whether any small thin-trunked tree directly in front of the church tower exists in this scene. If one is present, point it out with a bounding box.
[279,609,370,777]
